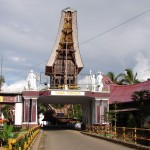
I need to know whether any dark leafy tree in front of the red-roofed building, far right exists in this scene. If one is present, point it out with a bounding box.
[131,90,150,127]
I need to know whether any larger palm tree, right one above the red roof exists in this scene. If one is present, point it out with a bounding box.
[121,68,139,85]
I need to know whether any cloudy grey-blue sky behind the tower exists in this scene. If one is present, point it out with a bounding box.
[0,0,150,91]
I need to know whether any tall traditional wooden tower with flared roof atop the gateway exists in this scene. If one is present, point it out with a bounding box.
[45,8,83,88]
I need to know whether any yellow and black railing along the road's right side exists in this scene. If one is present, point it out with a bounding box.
[86,125,150,146]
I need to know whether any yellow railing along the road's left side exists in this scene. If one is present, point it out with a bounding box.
[8,126,40,150]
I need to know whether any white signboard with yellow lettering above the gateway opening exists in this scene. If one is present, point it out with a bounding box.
[51,91,85,96]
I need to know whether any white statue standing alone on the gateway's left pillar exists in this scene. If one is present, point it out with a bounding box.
[27,70,37,90]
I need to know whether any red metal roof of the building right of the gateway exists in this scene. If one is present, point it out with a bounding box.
[109,81,150,104]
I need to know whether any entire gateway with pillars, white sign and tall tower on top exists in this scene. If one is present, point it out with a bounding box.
[23,8,111,126]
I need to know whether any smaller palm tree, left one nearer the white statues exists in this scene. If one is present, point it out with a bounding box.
[107,71,124,84]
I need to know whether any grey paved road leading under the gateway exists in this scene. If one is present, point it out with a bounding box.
[37,130,133,150]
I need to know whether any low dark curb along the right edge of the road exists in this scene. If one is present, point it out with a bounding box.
[81,131,150,150]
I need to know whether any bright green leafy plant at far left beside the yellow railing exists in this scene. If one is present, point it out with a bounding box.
[0,122,14,145]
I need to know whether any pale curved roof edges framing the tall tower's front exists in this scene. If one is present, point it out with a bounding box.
[45,7,84,75]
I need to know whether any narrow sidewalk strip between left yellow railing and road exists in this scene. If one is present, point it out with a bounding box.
[30,130,43,150]
